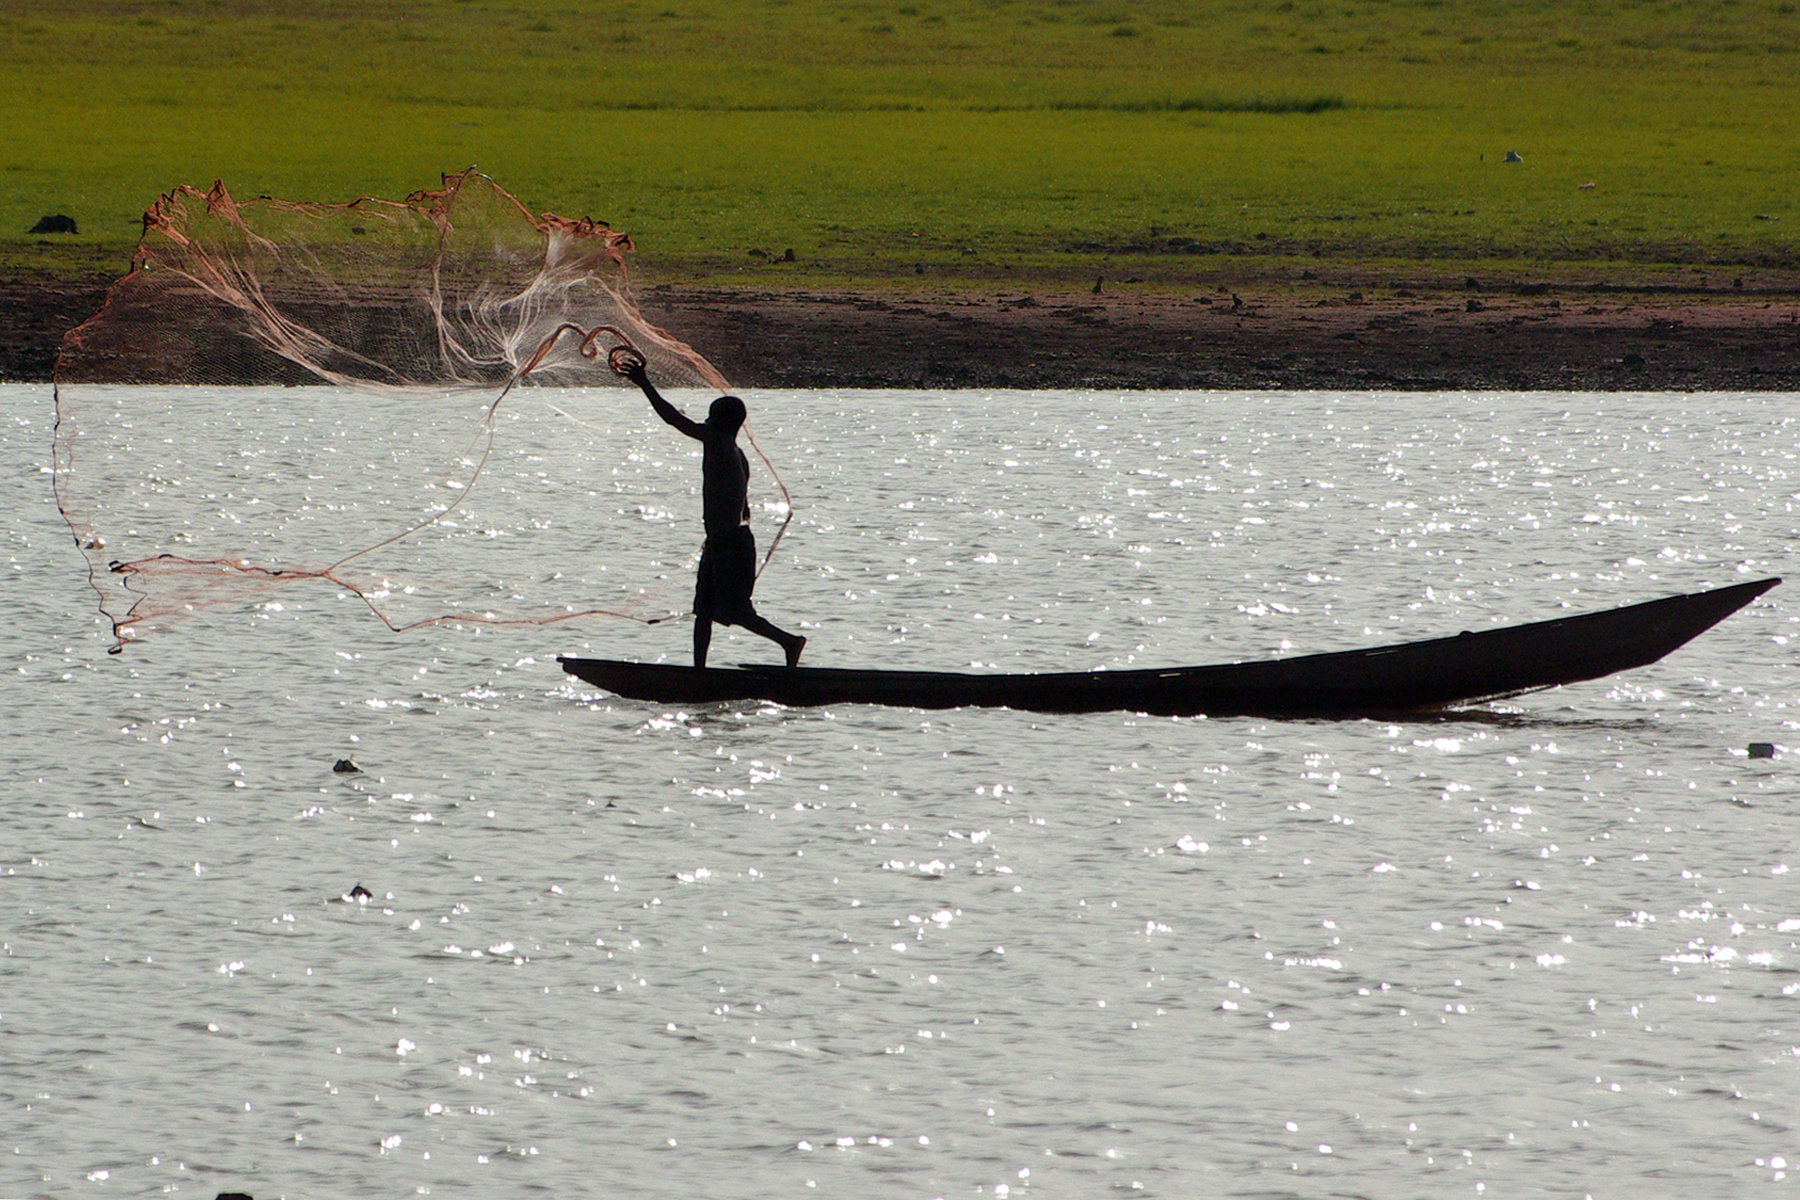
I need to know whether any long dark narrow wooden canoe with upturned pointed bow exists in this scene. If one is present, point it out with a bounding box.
[560,579,1780,716]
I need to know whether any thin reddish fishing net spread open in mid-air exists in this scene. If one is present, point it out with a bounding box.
[54,171,787,651]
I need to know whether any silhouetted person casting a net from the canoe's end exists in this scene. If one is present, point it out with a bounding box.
[610,347,806,667]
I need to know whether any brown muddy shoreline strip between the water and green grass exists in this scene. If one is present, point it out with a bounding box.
[0,275,1800,392]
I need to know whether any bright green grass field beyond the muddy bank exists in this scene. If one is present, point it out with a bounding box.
[0,0,1800,286]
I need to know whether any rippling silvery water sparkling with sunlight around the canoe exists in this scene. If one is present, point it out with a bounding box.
[0,387,1800,1198]
